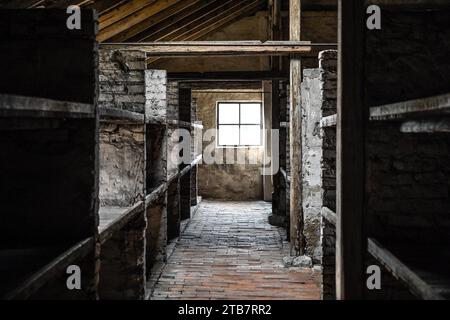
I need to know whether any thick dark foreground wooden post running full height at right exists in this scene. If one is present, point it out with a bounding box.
[336,0,368,299]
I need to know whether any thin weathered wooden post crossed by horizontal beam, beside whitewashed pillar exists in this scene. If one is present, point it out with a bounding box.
[289,0,305,256]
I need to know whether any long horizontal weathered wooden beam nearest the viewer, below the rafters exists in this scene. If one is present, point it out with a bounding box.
[102,41,311,57]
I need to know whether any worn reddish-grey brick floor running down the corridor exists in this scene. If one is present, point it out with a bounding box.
[151,201,320,300]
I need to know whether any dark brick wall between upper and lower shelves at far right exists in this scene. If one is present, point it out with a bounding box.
[367,122,450,244]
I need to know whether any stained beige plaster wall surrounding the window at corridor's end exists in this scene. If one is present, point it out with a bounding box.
[193,91,264,201]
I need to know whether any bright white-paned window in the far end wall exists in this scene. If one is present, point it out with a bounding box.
[217,102,262,147]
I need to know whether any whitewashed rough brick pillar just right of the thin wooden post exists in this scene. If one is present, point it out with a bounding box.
[301,50,337,262]
